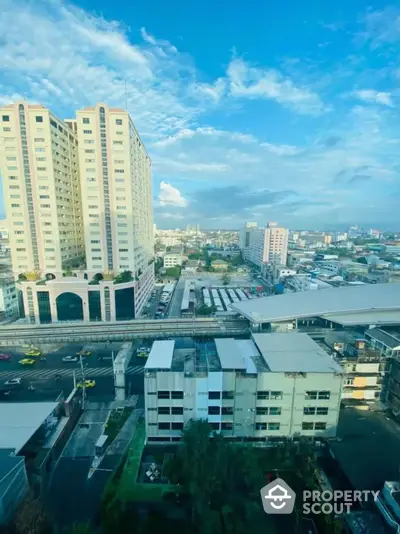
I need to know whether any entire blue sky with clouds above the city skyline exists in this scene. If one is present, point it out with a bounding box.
[0,0,400,229]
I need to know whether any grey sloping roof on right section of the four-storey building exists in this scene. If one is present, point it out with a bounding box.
[253,333,344,373]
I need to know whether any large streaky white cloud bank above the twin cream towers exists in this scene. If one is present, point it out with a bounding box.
[0,0,199,139]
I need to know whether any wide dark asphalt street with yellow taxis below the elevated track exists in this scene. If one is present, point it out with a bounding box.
[0,341,145,401]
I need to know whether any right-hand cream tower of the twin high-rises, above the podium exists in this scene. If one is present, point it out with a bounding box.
[77,104,153,276]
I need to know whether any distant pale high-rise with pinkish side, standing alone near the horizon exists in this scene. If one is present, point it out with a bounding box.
[241,223,289,267]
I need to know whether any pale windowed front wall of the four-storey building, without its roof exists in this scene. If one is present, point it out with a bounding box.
[145,371,343,441]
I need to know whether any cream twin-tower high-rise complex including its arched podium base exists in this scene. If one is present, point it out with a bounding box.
[0,103,154,323]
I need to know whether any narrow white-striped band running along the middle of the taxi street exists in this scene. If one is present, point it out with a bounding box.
[0,365,144,380]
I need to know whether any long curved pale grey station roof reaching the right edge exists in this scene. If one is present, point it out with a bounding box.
[231,284,400,324]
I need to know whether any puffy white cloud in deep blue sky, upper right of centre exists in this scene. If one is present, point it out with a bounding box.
[227,58,324,115]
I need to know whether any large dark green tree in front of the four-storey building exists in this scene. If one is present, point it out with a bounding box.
[170,420,282,534]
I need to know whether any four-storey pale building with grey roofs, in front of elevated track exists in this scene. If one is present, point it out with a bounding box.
[145,333,343,443]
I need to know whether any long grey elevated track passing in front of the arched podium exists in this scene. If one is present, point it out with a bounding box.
[0,318,249,346]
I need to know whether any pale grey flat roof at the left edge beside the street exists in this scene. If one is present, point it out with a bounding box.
[0,402,59,454]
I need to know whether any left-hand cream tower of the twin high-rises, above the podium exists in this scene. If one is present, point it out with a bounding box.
[0,102,84,278]
